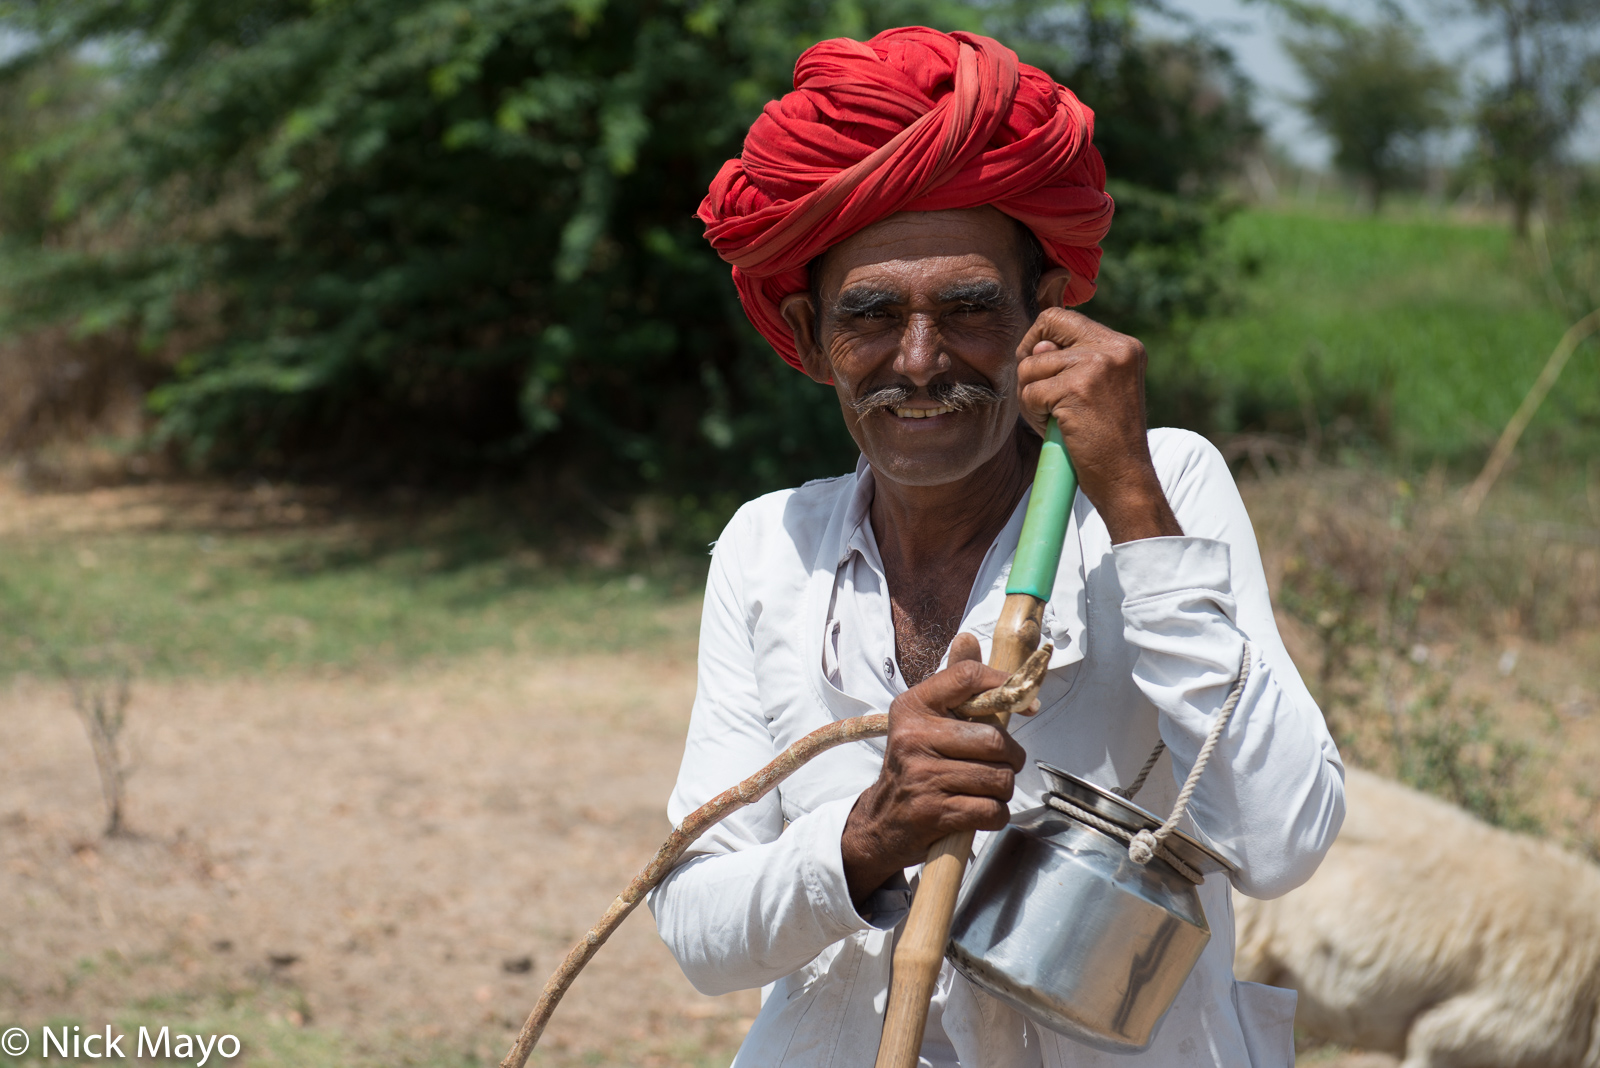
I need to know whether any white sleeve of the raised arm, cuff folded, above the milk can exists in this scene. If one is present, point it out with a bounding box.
[1114,433,1344,897]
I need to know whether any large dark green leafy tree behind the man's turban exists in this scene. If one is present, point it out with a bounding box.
[0,0,1245,492]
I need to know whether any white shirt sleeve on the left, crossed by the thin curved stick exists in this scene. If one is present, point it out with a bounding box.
[648,505,898,994]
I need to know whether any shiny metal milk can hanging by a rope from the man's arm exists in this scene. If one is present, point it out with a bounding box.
[947,756,1230,1054]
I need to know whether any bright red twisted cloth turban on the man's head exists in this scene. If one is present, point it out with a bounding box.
[699,27,1112,368]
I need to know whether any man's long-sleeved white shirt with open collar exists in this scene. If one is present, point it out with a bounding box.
[650,430,1344,1068]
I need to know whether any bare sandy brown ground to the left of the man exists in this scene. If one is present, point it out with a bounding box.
[0,659,757,1065]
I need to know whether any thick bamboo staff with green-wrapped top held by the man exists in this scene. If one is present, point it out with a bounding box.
[877,417,1078,1068]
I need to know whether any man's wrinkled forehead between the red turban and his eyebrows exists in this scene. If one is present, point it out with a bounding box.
[811,206,1024,297]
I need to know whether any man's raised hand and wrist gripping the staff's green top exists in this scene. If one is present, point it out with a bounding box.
[1018,309,1184,544]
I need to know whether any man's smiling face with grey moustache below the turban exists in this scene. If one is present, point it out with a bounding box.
[786,208,1043,486]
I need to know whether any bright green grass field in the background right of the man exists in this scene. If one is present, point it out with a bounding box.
[1184,209,1600,467]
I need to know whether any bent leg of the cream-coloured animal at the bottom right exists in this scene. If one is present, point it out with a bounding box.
[1400,991,1578,1068]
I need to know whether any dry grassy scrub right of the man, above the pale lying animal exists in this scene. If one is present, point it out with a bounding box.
[1243,468,1600,857]
